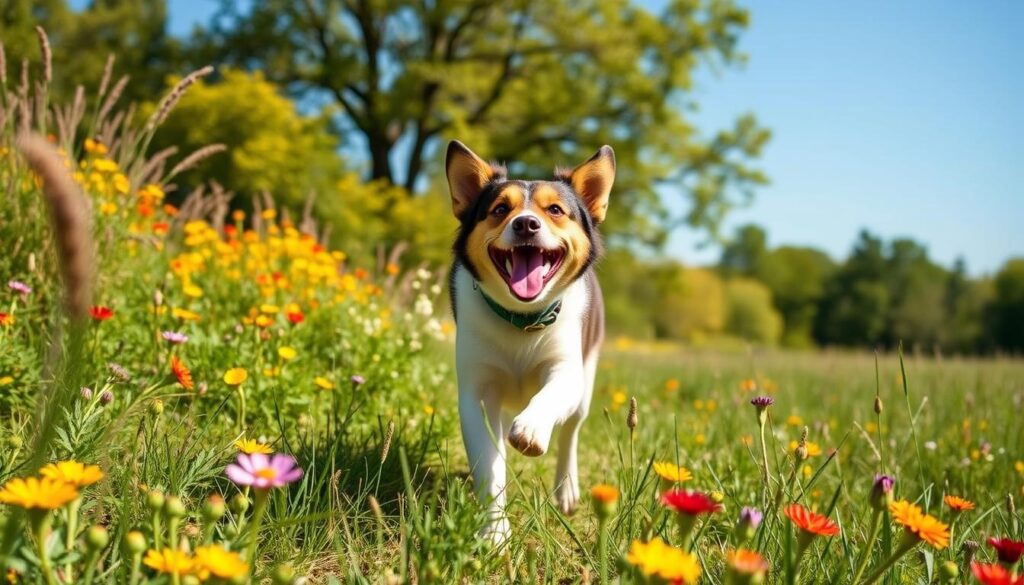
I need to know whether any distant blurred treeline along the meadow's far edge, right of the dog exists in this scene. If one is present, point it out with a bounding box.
[600,225,1024,353]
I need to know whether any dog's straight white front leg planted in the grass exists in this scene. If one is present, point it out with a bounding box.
[459,386,509,543]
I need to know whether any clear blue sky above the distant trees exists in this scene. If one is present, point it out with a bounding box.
[73,0,1024,275]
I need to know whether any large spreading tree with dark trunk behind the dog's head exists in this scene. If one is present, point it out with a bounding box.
[195,0,769,244]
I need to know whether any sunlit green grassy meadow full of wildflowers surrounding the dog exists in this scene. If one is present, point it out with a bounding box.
[0,30,1024,584]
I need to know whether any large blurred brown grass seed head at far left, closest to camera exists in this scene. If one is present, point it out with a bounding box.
[17,134,95,322]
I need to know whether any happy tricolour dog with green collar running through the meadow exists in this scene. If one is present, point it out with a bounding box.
[444,140,615,542]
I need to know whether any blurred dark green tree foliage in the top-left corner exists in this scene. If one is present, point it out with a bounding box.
[0,0,183,101]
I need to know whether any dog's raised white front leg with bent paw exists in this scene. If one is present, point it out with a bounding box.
[508,361,585,457]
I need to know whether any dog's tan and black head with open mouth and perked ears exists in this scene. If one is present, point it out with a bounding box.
[445,140,615,311]
